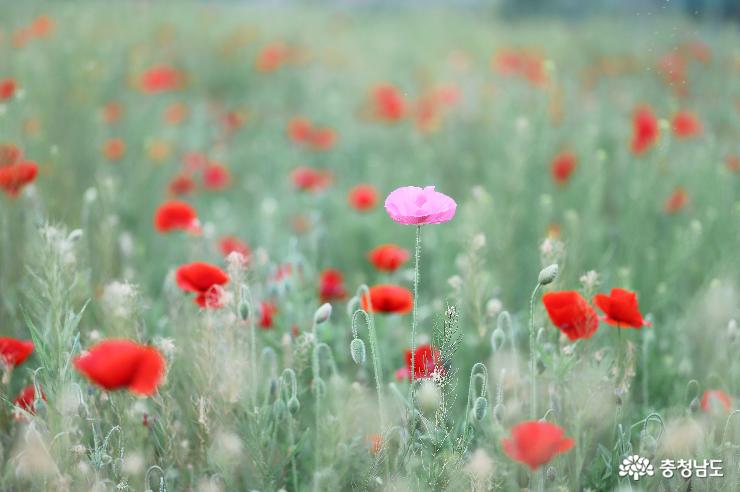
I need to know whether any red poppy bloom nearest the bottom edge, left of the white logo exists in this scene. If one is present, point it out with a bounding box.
[501,420,574,470]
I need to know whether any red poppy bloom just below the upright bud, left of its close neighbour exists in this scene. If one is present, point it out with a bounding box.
[542,290,599,341]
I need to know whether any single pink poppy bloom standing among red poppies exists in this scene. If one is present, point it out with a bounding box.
[385,186,457,225]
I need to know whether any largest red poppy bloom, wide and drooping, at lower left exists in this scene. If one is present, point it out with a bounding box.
[72,339,165,396]
